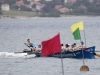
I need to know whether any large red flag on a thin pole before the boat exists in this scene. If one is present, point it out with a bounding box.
[42,34,61,56]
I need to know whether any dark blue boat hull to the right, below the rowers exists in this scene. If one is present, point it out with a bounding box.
[51,46,95,59]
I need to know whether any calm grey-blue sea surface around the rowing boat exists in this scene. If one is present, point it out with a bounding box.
[0,17,100,75]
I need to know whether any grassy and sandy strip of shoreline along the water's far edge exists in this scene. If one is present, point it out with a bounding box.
[0,11,100,19]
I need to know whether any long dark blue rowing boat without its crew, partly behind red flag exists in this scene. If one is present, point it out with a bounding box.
[25,46,95,59]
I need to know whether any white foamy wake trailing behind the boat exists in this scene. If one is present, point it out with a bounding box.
[0,52,36,58]
